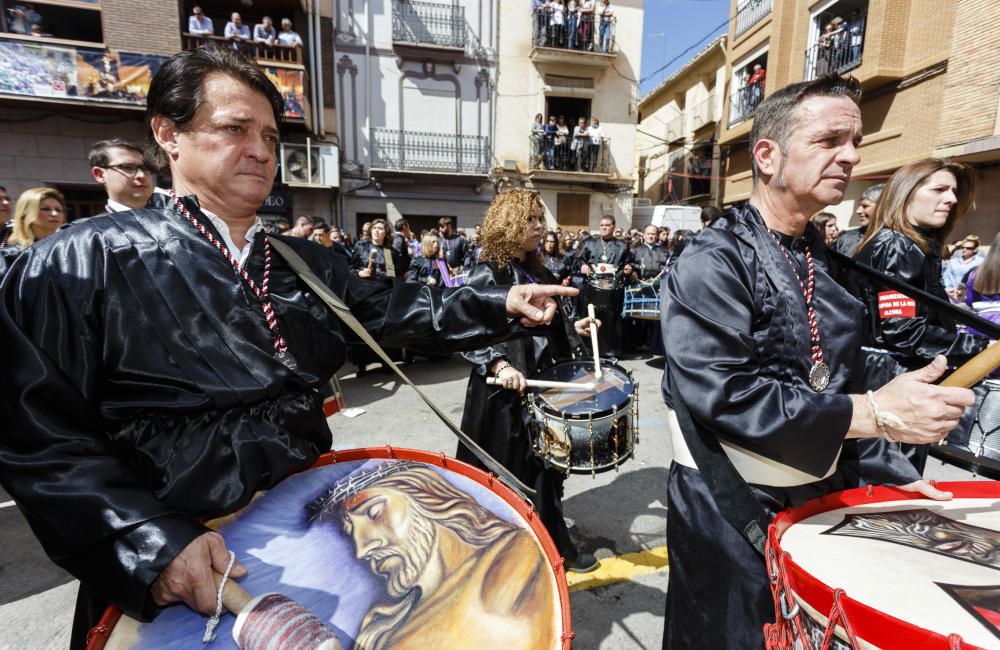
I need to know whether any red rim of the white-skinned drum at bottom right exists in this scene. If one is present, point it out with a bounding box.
[768,481,1000,649]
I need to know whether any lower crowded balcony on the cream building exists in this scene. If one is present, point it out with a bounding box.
[528,134,611,183]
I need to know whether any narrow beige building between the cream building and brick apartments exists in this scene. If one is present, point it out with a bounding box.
[636,36,726,206]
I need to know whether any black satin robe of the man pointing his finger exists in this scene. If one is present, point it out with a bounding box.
[0,194,516,619]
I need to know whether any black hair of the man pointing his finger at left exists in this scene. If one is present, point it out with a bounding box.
[146,47,285,169]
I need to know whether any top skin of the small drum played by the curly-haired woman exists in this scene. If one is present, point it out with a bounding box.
[537,360,634,419]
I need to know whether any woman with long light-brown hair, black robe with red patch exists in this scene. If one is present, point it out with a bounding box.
[847,158,989,473]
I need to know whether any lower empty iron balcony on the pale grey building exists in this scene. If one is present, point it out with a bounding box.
[372,127,490,176]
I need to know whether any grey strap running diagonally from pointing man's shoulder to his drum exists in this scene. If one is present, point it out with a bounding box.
[268,237,535,501]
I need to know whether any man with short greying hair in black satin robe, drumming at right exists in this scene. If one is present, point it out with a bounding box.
[662,77,973,648]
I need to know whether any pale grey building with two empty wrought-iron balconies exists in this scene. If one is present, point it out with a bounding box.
[333,0,499,233]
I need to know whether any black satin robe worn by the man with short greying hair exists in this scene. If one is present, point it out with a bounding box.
[663,205,919,650]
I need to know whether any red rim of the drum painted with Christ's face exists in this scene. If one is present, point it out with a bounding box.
[87,445,576,650]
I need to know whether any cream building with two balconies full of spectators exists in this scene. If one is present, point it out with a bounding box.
[491,0,643,229]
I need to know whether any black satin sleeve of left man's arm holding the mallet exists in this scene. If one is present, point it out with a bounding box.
[0,233,206,619]
